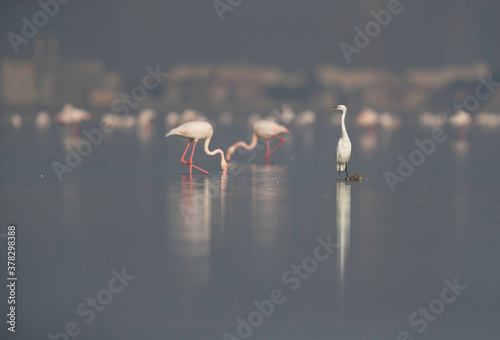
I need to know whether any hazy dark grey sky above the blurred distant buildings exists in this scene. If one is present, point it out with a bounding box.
[0,0,500,80]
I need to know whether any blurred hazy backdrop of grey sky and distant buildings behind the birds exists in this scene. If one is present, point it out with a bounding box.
[0,0,500,121]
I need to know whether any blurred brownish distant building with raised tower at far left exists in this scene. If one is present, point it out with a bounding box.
[0,35,123,111]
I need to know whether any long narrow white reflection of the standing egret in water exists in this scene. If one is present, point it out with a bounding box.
[337,182,351,319]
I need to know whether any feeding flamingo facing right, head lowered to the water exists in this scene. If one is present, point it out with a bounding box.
[165,120,227,175]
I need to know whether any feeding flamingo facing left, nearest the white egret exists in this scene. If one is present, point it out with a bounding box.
[226,120,290,164]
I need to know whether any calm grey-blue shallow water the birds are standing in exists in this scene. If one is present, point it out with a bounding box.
[0,126,500,339]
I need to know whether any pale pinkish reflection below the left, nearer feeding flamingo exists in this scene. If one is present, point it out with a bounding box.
[165,175,227,327]
